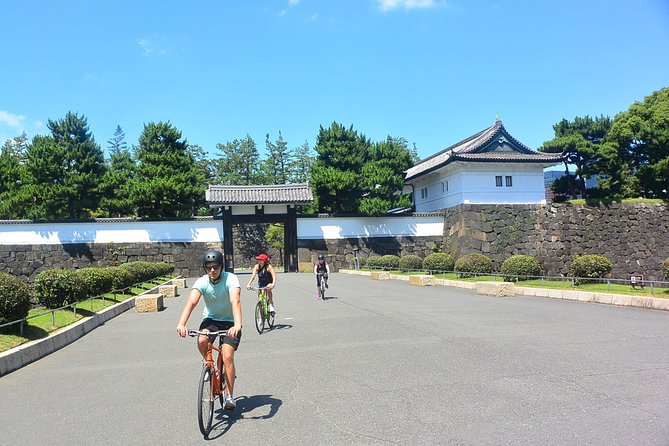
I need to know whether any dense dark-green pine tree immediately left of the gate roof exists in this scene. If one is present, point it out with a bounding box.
[130,122,206,218]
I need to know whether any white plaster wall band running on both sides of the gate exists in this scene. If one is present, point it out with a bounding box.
[0,216,444,245]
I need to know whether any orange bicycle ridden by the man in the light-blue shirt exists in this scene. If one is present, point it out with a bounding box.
[188,330,228,437]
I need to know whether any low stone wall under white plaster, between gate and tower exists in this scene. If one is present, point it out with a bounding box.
[297,237,442,271]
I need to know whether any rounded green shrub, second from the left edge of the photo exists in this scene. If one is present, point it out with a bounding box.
[35,268,88,308]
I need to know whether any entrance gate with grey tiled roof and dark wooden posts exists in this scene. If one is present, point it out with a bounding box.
[206,183,314,272]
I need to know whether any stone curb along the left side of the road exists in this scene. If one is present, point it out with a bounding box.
[0,278,180,377]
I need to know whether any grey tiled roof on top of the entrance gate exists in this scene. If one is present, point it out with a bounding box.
[206,183,314,205]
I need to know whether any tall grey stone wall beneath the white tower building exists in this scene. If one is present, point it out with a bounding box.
[444,203,669,280]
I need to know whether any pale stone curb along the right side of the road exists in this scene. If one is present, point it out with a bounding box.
[339,269,669,311]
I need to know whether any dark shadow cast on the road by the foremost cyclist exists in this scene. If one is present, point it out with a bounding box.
[205,395,283,440]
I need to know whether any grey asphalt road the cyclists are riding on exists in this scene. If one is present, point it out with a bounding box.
[0,274,669,446]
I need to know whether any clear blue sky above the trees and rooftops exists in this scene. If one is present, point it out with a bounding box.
[0,0,669,164]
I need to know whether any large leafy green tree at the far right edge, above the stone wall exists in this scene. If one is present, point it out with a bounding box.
[600,87,669,197]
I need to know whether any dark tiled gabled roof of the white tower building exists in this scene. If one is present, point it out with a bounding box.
[405,120,563,181]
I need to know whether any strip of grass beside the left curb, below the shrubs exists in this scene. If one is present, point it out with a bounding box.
[0,277,171,352]
